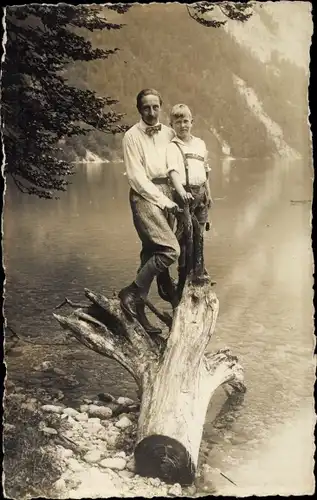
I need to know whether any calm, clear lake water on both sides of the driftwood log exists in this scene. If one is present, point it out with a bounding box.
[4,160,314,495]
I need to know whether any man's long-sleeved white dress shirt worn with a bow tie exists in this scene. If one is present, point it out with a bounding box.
[122,120,175,209]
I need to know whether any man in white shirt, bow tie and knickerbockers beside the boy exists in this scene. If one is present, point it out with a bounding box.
[119,89,180,334]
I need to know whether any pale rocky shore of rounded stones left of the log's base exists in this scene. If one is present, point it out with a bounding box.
[5,382,211,498]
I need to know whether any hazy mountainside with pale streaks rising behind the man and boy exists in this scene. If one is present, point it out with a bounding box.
[62,2,311,159]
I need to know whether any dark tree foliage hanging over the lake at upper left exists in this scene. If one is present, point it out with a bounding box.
[1,4,129,198]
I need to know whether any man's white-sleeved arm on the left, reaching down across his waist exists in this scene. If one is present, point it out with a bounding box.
[122,136,175,210]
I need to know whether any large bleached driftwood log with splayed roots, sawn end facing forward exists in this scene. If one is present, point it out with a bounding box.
[54,204,245,485]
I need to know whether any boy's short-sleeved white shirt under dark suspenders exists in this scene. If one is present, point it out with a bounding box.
[166,136,210,186]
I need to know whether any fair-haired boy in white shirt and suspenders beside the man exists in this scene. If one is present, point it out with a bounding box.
[166,104,216,284]
